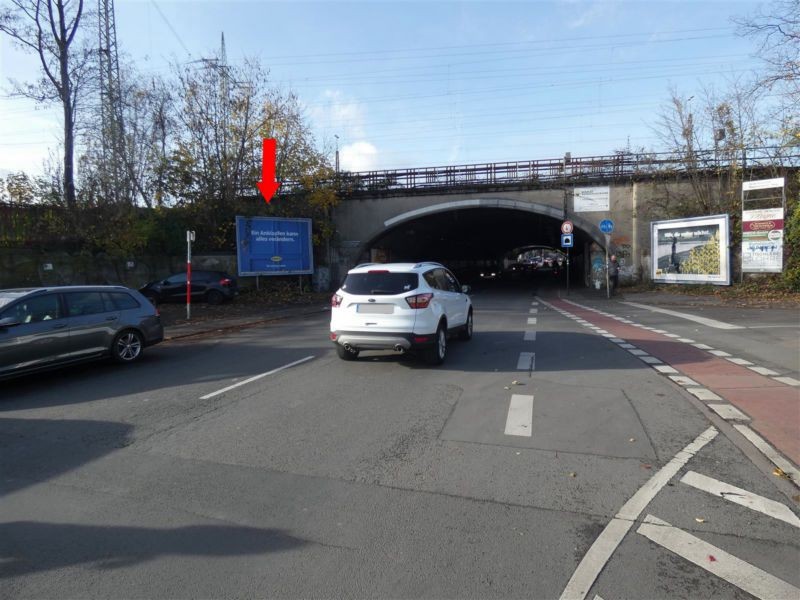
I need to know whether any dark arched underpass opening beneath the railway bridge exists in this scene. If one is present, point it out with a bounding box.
[361,208,593,286]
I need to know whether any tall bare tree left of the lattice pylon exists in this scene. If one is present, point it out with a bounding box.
[0,0,94,209]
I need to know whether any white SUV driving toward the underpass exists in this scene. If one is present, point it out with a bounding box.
[331,262,472,365]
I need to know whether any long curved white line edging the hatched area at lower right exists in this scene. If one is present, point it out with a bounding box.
[561,427,719,600]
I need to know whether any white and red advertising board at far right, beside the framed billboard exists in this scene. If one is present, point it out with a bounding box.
[742,208,783,273]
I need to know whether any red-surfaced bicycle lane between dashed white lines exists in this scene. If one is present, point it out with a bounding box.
[548,299,800,465]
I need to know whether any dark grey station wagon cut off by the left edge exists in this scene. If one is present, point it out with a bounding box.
[0,285,164,379]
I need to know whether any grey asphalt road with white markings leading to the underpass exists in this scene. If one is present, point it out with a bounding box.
[0,289,800,600]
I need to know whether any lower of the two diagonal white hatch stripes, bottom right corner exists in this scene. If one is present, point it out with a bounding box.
[636,515,800,599]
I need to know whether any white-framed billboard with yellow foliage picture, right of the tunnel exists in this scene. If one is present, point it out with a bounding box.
[650,215,730,285]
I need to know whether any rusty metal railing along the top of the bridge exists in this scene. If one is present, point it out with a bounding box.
[281,148,800,193]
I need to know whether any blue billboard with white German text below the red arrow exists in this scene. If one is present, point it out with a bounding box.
[236,217,314,276]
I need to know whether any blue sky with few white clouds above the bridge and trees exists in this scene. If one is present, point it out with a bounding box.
[0,0,760,173]
